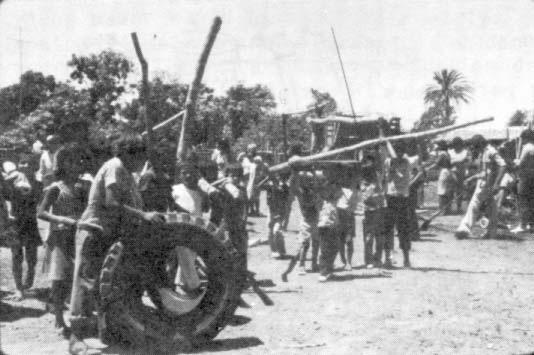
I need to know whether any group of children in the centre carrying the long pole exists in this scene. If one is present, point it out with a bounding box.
[264,141,428,282]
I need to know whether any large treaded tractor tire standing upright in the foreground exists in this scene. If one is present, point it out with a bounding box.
[99,214,241,345]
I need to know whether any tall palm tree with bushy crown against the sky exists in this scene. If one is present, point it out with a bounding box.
[425,69,473,126]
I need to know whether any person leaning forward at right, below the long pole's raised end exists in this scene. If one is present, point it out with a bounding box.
[454,134,506,239]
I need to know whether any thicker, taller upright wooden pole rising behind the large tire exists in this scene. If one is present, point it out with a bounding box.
[176,17,222,162]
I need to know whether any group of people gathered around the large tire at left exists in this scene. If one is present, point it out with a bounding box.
[0,135,255,353]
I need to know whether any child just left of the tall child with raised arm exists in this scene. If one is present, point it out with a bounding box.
[360,164,386,268]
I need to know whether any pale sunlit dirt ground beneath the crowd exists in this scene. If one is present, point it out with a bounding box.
[0,186,534,355]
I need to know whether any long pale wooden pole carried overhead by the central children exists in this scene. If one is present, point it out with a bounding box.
[269,117,493,173]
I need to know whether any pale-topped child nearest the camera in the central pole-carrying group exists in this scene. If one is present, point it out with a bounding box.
[317,170,341,282]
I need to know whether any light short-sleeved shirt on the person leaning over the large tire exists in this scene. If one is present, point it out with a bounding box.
[80,158,143,234]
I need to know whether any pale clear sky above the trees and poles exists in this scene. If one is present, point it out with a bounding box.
[0,0,534,127]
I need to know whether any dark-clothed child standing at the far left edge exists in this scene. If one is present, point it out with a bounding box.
[3,162,42,300]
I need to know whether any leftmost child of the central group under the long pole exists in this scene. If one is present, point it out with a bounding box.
[263,175,289,259]
